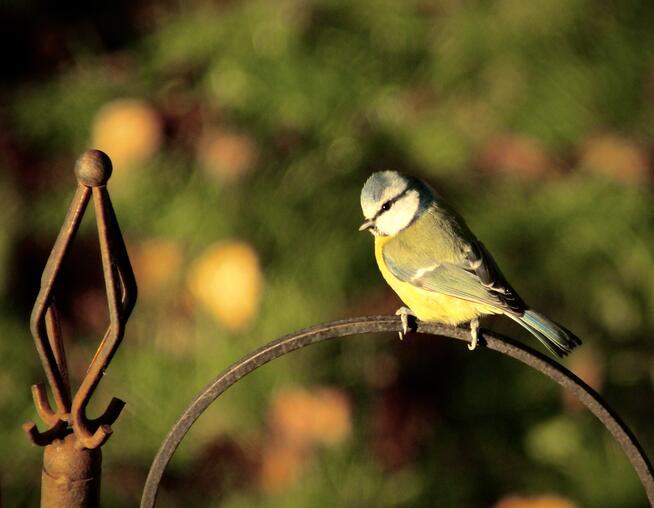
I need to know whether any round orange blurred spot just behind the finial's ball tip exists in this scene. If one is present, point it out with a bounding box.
[91,99,163,175]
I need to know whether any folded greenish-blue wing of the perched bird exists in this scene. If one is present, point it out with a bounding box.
[382,236,526,315]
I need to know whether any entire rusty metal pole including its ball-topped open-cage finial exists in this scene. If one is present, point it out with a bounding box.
[23,150,136,508]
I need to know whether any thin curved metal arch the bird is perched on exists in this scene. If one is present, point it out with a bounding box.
[141,316,654,508]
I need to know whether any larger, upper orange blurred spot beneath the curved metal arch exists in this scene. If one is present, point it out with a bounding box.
[270,388,351,446]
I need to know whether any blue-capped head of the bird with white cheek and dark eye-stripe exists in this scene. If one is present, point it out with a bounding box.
[359,171,434,236]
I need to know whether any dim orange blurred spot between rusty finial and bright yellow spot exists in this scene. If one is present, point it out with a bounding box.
[129,238,183,295]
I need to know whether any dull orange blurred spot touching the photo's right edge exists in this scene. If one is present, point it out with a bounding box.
[579,134,651,183]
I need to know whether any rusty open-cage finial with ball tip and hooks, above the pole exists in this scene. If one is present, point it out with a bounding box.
[24,150,136,449]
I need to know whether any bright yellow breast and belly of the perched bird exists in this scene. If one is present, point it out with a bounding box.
[375,236,494,325]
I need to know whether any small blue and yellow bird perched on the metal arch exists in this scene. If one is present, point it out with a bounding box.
[359,171,581,357]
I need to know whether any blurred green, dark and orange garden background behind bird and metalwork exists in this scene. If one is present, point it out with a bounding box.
[0,0,654,508]
